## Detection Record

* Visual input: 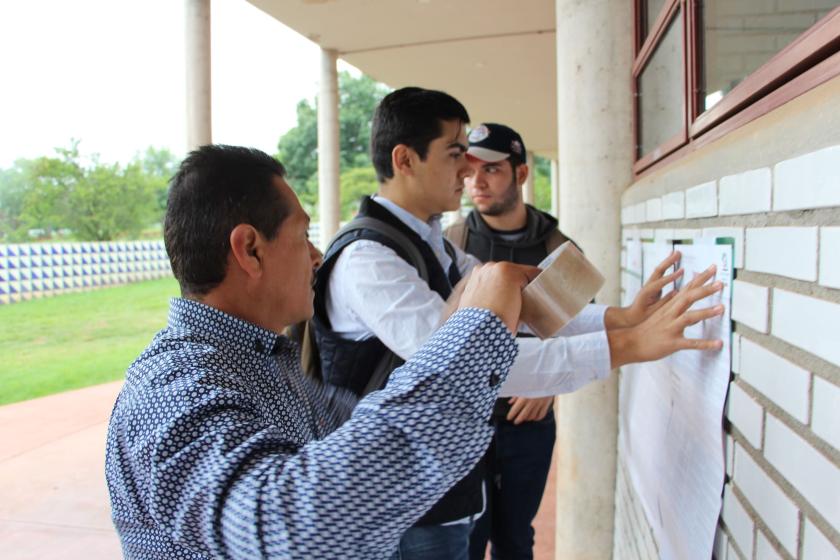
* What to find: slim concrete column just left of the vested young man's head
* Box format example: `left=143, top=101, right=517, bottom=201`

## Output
left=318, top=49, right=341, bottom=249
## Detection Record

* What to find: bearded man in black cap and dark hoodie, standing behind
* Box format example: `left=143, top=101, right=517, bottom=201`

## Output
left=446, top=123, right=568, bottom=559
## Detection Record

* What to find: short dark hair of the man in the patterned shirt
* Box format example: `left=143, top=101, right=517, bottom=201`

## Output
left=163, top=145, right=290, bottom=296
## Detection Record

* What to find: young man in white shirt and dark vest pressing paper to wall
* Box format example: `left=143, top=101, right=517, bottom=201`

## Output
left=315, top=88, right=722, bottom=560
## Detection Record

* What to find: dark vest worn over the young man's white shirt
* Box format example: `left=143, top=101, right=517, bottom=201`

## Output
left=312, top=197, right=483, bottom=525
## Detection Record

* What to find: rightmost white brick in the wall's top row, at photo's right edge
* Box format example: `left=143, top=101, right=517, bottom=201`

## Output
left=773, top=146, right=840, bottom=211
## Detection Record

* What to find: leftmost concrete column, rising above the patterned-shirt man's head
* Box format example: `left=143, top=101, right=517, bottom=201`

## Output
left=184, top=0, right=213, bottom=150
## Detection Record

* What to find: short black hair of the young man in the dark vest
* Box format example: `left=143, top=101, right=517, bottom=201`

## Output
left=370, top=87, right=470, bottom=183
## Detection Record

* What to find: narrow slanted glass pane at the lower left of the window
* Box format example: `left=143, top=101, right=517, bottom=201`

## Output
left=636, top=11, right=685, bottom=157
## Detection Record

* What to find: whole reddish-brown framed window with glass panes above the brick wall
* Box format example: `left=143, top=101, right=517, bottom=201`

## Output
left=633, top=0, right=840, bottom=174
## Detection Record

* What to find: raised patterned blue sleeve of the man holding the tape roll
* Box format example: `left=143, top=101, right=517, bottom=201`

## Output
left=153, top=309, right=516, bottom=558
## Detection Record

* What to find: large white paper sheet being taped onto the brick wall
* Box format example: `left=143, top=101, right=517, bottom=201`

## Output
left=620, top=241, right=732, bottom=560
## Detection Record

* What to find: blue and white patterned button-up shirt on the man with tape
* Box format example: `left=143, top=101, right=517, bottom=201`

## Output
left=106, top=299, right=516, bottom=559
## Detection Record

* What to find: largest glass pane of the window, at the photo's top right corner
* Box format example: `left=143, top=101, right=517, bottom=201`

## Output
left=699, top=0, right=840, bottom=112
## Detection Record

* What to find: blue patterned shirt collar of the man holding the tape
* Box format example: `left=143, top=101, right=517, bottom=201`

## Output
left=169, top=298, right=292, bottom=356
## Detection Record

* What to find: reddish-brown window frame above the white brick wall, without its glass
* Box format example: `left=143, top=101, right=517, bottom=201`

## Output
left=632, top=0, right=840, bottom=177
